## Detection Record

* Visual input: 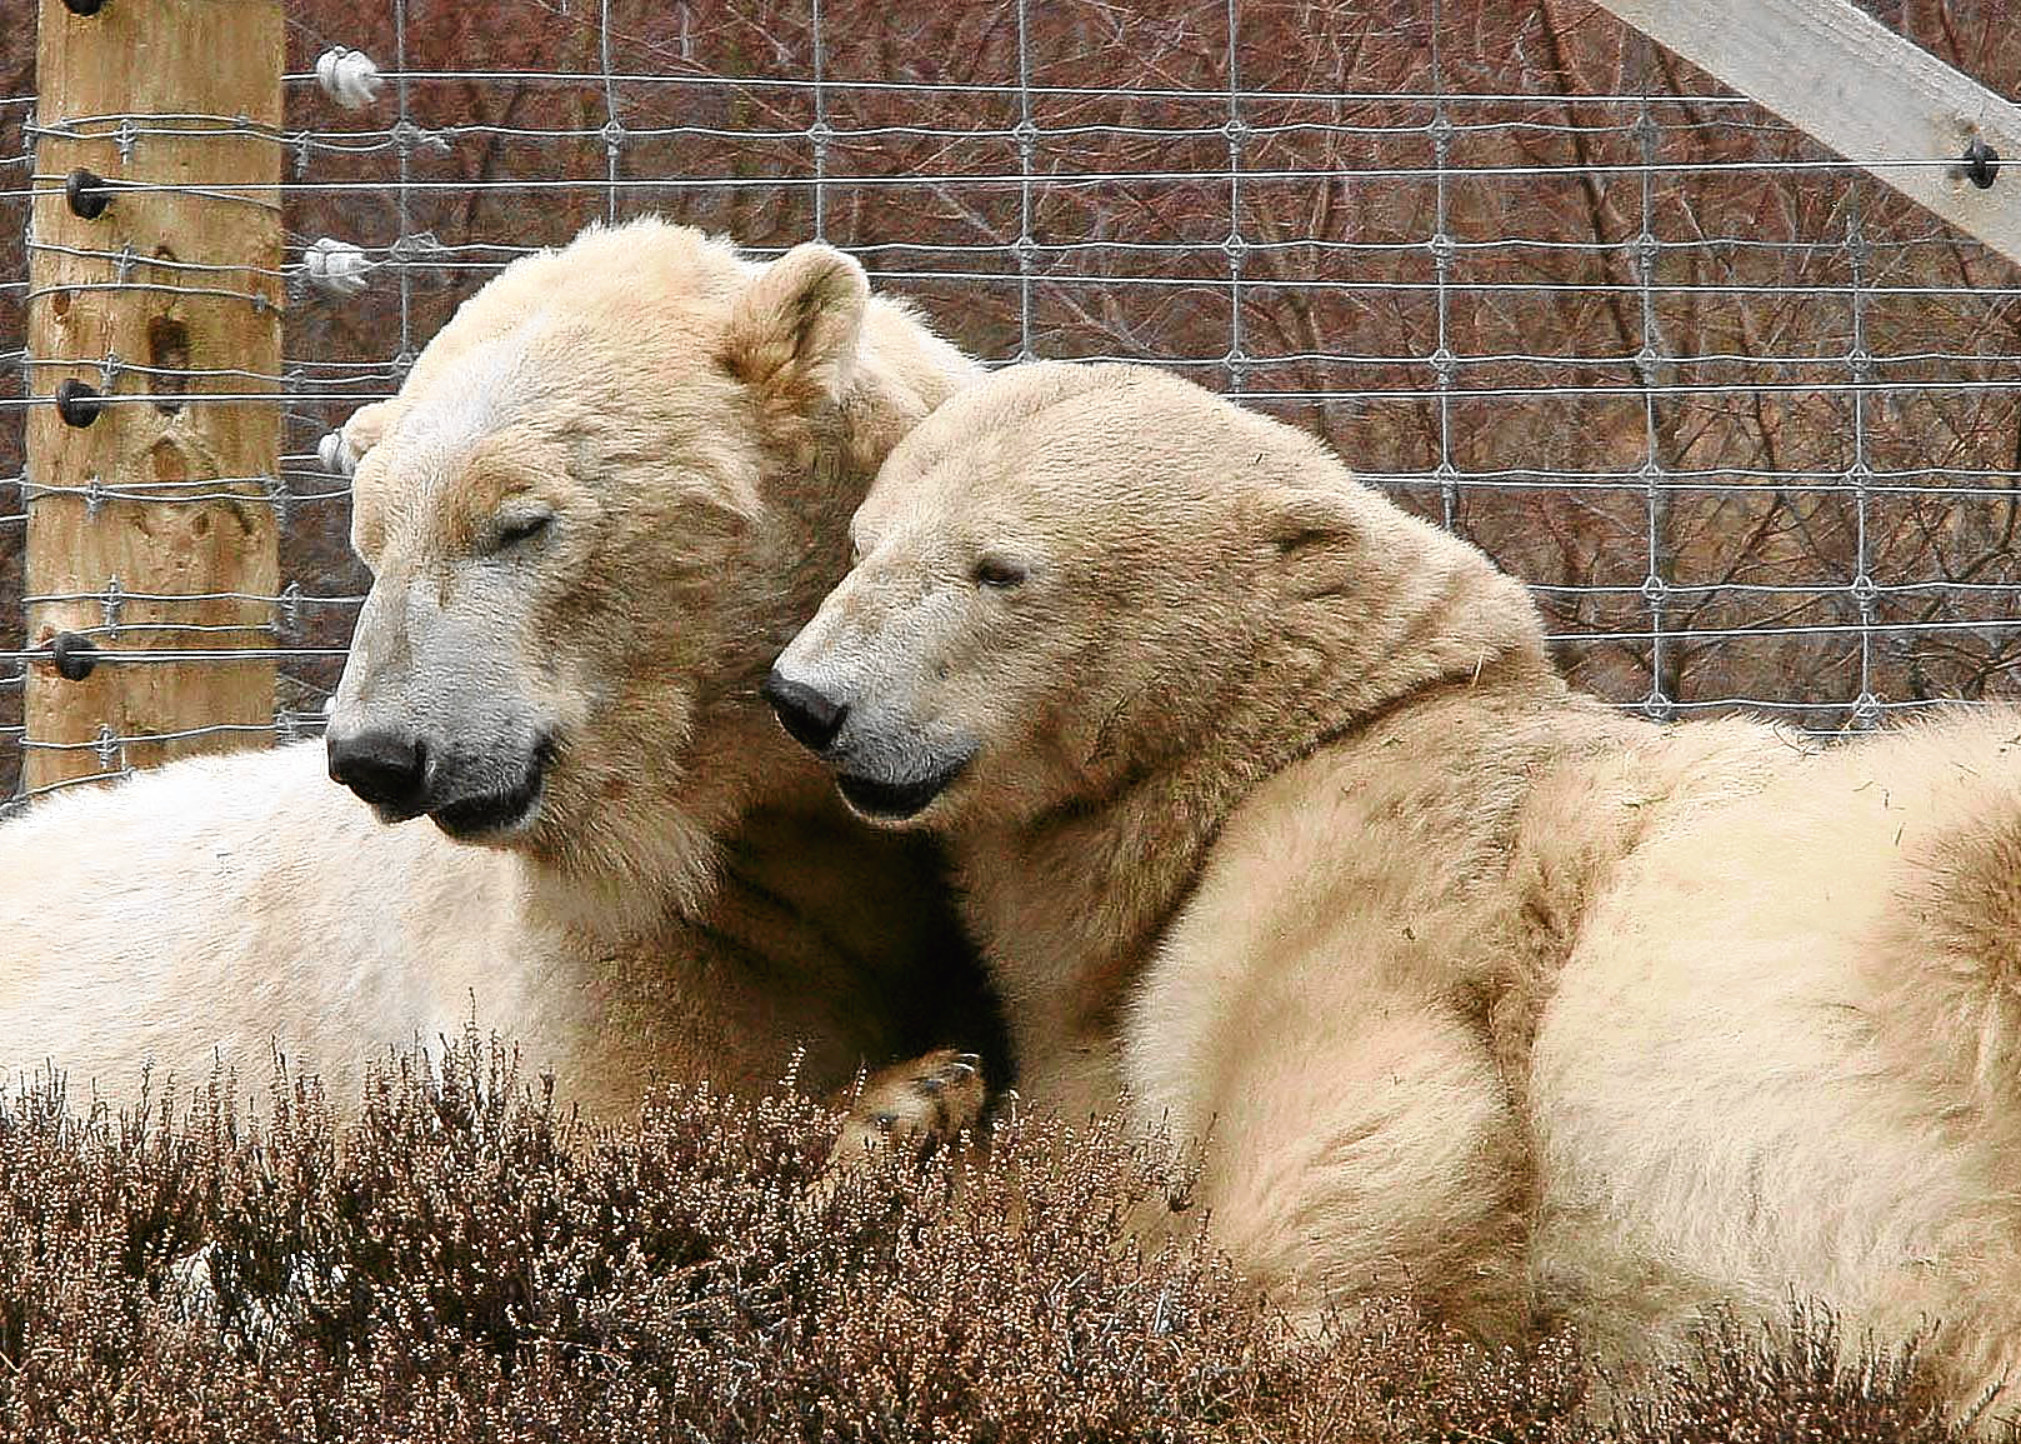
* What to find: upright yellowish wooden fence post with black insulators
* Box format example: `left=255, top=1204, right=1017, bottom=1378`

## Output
left=22, top=0, right=285, bottom=789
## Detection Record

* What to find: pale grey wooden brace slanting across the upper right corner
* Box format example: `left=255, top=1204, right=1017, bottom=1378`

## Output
left=1599, top=0, right=2021, bottom=263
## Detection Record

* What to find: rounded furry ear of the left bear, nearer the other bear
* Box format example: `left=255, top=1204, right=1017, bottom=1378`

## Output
left=721, top=241, right=871, bottom=402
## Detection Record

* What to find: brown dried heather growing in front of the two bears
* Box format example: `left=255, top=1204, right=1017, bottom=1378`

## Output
left=0, top=1033, right=1988, bottom=1444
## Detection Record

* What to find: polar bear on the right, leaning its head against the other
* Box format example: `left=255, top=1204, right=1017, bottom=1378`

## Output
left=766, top=364, right=2021, bottom=1408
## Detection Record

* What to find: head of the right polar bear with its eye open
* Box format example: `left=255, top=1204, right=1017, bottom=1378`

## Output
left=766, top=362, right=1542, bottom=825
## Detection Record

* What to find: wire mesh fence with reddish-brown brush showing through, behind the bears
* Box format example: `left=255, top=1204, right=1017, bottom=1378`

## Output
left=0, top=0, right=2021, bottom=796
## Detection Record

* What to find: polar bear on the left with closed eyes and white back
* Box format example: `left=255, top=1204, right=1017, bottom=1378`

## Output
left=0, top=220, right=1006, bottom=1112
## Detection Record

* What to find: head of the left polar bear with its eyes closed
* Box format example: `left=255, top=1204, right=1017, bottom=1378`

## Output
left=327, top=220, right=970, bottom=896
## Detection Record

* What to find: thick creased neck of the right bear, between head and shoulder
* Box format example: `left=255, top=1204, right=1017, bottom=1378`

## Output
left=958, top=489, right=1566, bottom=1075
